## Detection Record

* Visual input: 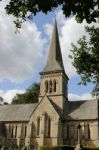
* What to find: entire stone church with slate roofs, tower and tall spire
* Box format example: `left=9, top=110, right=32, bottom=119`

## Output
left=0, top=21, right=99, bottom=146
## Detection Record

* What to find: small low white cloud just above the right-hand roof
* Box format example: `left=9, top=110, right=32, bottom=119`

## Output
left=68, top=93, right=95, bottom=101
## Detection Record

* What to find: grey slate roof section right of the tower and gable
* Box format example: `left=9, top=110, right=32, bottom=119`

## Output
left=64, top=100, right=98, bottom=120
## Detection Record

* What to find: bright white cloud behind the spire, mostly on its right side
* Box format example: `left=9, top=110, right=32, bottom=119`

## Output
left=45, top=10, right=97, bottom=77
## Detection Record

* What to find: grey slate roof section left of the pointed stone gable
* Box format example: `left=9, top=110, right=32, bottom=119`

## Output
left=0, top=103, right=37, bottom=122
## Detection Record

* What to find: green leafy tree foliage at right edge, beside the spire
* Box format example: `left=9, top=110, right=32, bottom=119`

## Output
left=70, top=26, right=99, bottom=94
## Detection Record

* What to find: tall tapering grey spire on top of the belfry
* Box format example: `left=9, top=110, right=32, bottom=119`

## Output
left=42, top=20, right=64, bottom=73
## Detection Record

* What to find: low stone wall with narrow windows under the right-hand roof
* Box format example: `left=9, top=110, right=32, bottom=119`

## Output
left=63, top=120, right=99, bottom=147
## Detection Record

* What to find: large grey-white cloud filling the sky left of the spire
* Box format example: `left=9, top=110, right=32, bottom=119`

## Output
left=0, top=1, right=46, bottom=83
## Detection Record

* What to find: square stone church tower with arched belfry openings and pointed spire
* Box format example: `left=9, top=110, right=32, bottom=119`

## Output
left=39, top=20, right=68, bottom=109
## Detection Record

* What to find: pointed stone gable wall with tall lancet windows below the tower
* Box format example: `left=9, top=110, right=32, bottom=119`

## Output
left=27, top=96, right=59, bottom=146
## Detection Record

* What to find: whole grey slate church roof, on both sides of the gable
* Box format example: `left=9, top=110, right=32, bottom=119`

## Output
left=0, top=99, right=98, bottom=122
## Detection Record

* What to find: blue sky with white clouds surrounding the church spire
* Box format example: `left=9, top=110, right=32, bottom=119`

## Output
left=0, top=0, right=97, bottom=102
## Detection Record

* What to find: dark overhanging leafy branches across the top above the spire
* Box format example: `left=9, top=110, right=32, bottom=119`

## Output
left=2, top=0, right=99, bottom=28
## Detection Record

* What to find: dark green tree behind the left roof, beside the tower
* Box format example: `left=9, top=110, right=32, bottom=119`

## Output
left=12, top=83, right=40, bottom=104
